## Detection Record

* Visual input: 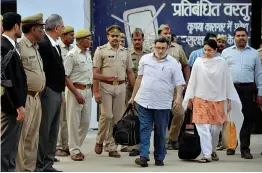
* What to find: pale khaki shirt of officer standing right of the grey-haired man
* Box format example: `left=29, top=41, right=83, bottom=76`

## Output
left=64, top=46, right=93, bottom=85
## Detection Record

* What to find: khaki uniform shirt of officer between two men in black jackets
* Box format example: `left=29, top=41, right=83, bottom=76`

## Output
left=19, top=36, right=46, bottom=92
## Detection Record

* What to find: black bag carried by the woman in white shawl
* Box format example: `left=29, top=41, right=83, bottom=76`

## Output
left=178, top=109, right=201, bottom=160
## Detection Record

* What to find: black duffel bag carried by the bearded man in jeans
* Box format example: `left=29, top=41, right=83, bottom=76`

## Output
left=113, top=104, right=140, bottom=146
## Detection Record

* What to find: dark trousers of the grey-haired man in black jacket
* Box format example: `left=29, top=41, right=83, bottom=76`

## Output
left=35, top=87, right=62, bottom=172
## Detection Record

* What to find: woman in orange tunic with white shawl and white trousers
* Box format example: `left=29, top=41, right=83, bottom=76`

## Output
left=183, top=40, right=243, bottom=163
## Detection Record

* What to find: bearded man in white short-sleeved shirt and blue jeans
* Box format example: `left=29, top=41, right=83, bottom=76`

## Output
left=129, top=36, right=185, bottom=167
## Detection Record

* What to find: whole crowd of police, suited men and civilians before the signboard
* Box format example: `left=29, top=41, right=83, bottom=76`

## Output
left=1, top=12, right=262, bottom=172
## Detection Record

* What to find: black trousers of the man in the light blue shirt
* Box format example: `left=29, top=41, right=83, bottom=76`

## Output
left=235, top=84, right=255, bottom=153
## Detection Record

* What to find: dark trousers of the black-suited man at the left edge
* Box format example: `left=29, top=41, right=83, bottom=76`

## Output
left=1, top=112, right=23, bottom=172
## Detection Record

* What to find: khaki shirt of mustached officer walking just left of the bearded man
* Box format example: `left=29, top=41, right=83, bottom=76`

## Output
left=94, top=43, right=133, bottom=81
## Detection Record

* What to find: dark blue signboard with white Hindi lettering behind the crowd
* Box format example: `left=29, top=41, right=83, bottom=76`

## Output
left=93, top=0, right=251, bottom=54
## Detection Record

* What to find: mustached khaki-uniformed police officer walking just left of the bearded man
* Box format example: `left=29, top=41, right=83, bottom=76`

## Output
left=94, top=25, right=135, bottom=158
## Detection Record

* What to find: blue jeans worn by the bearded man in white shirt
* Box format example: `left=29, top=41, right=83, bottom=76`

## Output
left=138, top=104, right=170, bottom=161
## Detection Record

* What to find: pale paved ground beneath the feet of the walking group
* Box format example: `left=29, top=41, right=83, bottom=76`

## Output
left=54, top=131, right=262, bottom=172
